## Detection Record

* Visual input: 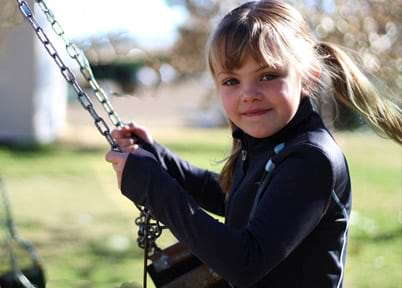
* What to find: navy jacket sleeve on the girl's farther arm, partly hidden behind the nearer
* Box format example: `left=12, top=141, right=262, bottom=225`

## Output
left=133, top=142, right=225, bottom=216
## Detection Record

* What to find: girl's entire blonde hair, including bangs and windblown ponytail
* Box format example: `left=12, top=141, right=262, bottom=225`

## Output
left=208, top=0, right=402, bottom=191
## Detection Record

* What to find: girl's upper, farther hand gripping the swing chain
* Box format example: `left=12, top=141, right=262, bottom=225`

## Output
left=111, top=122, right=154, bottom=153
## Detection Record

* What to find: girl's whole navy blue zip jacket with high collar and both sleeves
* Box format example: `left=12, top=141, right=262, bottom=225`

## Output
left=121, top=98, right=351, bottom=288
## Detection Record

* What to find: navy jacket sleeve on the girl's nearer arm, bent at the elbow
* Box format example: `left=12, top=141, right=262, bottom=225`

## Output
left=122, top=147, right=333, bottom=287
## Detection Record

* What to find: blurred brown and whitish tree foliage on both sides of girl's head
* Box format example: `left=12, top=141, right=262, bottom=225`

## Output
left=169, top=0, right=402, bottom=83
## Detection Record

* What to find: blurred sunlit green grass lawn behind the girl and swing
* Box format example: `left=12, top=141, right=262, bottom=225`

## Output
left=0, top=130, right=402, bottom=288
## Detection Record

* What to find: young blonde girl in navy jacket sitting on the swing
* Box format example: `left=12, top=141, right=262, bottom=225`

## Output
left=106, top=0, right=402, bottom=288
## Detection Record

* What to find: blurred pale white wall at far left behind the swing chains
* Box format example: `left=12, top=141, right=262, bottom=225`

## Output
left=0, top=2, right=67, bottom=144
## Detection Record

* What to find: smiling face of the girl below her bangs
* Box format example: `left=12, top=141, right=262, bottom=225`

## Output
left=216, top=56, right=301, bottom=138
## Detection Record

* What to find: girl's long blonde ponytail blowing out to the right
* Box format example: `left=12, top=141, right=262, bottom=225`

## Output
left=316, top=42, right=402, bottom=144
